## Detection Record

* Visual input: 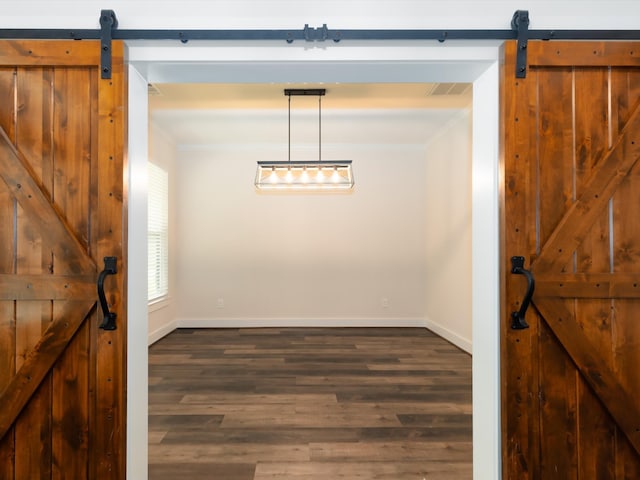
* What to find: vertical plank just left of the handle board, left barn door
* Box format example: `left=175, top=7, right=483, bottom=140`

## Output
left=52, top=64, right=95, bottom=479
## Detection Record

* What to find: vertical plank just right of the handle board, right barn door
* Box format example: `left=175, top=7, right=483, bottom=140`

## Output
left=535, top=68, right=578, bottom=479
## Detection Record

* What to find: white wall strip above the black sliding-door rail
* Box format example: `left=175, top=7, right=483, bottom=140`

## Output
left=5, top=0, right=640, bottom=29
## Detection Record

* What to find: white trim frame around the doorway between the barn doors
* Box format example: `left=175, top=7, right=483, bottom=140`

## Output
left=129, top=39, right=500, bottom=473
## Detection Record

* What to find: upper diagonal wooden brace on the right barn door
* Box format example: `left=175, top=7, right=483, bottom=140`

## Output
left=532, top=97, right=640, bottom=271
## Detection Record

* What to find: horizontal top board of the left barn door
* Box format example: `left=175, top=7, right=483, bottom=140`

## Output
left=0, top=40, right=100, bottom=67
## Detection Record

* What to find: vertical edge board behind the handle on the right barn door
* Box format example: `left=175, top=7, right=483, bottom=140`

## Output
left=501, top=42, right=540, bottom=479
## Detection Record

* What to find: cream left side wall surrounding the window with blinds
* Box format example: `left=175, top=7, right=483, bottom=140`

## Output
left=149, top=123, right=178, bottom=344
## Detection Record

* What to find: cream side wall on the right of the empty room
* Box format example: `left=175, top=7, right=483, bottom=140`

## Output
left=424, top=111, right=472, bottom=352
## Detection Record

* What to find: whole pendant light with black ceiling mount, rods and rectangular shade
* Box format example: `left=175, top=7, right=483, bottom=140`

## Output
left=255, top=88, right=353, bottom=190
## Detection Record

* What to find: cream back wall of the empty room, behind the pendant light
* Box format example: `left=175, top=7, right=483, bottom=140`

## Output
left=170, top=107, right=471, bottom=332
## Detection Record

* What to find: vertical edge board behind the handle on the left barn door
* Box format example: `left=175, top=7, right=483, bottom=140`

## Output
left=89, top=41, right=127, bottom=480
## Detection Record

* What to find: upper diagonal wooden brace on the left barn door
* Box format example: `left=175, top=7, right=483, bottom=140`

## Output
left=0, top=129, right=96, bottom=273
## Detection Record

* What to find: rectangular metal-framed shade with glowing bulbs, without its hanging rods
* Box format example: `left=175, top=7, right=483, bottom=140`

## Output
left=255, top=160, right=353, bottom=190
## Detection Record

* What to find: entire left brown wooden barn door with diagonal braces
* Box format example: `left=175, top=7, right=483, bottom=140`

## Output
left=0, top=41, right=126, bottom=480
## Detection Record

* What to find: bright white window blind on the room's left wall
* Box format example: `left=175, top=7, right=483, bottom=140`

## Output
left=147, top=163, right=169, bottom=302
